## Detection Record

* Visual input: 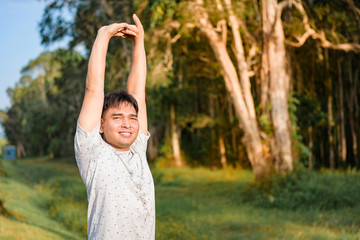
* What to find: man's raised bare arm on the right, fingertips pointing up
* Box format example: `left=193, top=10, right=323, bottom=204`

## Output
left=127, top=14, right=148, bottom=135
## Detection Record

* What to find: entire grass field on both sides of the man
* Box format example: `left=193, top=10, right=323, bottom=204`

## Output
left=0, top=158, right=360, bottom=240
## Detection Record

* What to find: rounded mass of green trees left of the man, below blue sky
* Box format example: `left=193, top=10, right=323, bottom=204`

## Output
left=3, top=49, right=85, bottom=157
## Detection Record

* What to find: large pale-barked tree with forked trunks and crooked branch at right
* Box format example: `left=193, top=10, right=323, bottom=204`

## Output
left=146, top=0, right=359, bottom=179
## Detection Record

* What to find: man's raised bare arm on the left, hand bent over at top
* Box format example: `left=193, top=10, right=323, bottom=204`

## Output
left=78, top=23, right=136, bottom=132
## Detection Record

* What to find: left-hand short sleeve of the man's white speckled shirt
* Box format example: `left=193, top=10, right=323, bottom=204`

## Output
left=74, top=123, right=101, bottom=181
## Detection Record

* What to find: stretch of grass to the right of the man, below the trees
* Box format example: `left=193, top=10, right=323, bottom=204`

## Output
left=153, top=169, right=360, bottom=240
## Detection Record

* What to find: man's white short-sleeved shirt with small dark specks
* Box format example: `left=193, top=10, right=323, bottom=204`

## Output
left=74, top=124, right=155, bottom=240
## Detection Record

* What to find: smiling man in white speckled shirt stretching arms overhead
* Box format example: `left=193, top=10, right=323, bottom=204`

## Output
left=74, top=14, right=155, bottom=240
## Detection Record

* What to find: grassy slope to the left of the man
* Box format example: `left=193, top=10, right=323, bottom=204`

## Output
left=0, top=159, right=86, bottom=239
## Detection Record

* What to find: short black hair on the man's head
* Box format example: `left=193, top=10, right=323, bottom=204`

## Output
left=101, top=91, right=139, bottom=117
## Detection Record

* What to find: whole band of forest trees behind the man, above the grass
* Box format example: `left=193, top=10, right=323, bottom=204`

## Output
left=1, top=0, right=360, bottom=180
